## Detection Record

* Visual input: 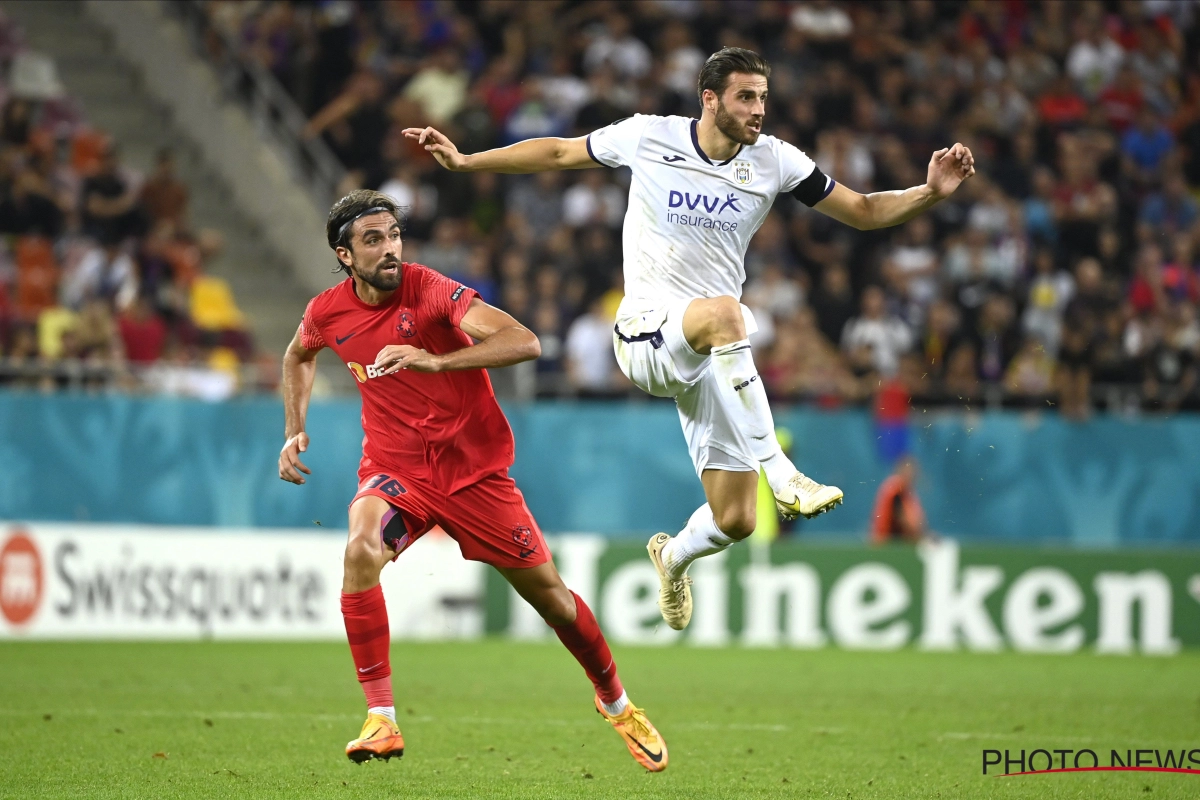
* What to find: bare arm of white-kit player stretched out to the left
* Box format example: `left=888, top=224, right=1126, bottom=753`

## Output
left=404, top=128, right=601, bottom=174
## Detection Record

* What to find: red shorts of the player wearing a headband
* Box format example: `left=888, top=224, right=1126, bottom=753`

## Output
left=350, top=471, right=550, bottom=569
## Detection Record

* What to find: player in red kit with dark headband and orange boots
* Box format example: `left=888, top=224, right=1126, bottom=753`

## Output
left=280, top=190, right=667, bottom=772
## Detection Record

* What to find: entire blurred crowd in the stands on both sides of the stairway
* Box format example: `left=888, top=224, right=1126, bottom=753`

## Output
left=0, top=0, right=1200, bottom=419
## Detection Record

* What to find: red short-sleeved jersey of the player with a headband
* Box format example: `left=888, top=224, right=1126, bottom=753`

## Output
left=300, top=263, right=514, bottom=494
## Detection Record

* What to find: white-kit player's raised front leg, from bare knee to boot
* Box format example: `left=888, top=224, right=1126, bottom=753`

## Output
left=683, top=295, right=842, bottom=519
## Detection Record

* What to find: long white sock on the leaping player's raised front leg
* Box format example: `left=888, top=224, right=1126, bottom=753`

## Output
left=712, top=339, right=796, bottom=492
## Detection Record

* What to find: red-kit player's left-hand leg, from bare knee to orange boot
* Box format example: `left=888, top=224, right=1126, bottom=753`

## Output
left=342, top=495, right=404, bottom=764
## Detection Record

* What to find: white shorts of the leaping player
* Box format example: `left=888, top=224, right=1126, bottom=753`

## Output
left=612, top=299, right=758, bottom=475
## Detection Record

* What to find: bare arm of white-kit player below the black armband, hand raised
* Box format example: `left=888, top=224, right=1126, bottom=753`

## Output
left=812, top=144, right=974, bottom=230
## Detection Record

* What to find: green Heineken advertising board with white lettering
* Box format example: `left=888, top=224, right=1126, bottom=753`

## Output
left=484, top=536, right=1200, bottom=655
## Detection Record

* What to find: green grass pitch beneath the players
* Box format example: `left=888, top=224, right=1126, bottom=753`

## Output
left=0, top=640, right=1200, bottom=800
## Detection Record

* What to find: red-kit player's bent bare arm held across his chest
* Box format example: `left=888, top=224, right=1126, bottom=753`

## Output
left=374, top=297, right=541, bottom=375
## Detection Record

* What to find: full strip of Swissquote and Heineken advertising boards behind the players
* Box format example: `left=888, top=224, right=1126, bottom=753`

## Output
left=0, top=524, right=1200, bottom=655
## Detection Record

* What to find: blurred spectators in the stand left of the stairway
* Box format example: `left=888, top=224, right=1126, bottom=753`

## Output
left=0, top=14, right=254, bottom=397
